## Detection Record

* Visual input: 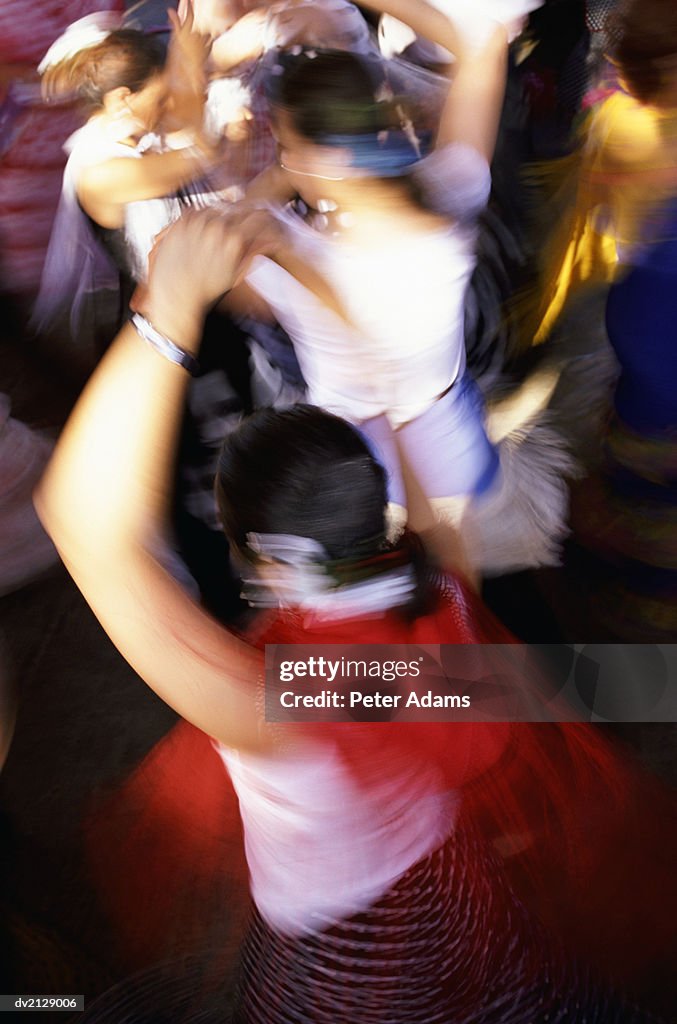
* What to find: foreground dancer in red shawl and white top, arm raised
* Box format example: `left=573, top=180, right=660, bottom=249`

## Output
left=37, top=213, right=671, bottom=1024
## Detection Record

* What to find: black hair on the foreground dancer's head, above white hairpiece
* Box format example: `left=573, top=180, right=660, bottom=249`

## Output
left=215, top=406, right=387, bottom=559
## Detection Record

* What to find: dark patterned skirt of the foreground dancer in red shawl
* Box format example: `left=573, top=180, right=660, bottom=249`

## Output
left=232, top=826, right=649, bottom=1024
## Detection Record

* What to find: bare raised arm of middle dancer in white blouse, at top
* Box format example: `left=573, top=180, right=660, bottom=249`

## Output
left=364, top=0, right=508, bottom=161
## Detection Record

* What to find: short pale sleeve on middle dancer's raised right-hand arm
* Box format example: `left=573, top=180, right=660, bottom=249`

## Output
left=414, top=142, right=492, bottom=222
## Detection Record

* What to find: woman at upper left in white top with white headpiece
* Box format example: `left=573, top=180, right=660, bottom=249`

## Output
left=34, top=14, right=248, bottom=614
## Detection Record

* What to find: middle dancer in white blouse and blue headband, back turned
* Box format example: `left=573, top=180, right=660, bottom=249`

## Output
left=234, top=0, right=570, bottom=573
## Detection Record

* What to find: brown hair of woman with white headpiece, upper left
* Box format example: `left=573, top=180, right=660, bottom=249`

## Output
left=42, top=29, right=165, bottom=106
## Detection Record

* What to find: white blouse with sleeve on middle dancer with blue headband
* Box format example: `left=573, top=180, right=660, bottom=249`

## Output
left=247, top=143, right=491, bottom=426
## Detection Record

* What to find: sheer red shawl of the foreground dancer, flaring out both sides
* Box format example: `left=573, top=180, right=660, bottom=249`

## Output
left=88, top=584, right=677, bottom=996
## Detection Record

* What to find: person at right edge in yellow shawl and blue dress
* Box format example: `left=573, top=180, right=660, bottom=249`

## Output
left=561, top=0, right=677, bottom=642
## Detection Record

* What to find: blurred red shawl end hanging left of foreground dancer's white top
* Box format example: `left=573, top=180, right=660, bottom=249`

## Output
left=86, top=722, right=249, bottom=971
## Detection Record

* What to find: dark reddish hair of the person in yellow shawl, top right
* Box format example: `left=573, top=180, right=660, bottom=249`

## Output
left=611, top=0, right=677, bottom=102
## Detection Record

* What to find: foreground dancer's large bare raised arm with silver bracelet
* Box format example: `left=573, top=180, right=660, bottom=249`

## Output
left=36, top=214, right=271, bottom=750
